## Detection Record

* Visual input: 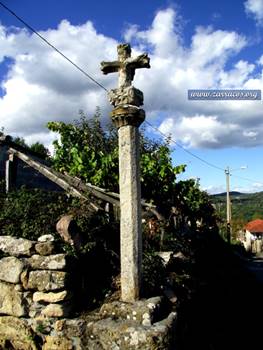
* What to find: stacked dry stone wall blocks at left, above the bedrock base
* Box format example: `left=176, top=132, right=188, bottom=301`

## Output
left=0, top=235, right=72, bottom=317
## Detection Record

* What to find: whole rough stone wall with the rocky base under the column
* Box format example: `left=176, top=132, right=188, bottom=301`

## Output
left=0, top=235, right=177, bottom=350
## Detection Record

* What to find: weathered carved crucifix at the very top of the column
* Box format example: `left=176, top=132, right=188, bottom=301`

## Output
left=101, top=44, right=150, bottom=88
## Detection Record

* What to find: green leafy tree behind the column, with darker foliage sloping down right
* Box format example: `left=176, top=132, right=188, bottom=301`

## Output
left=48, top=109, right=217, bottom=227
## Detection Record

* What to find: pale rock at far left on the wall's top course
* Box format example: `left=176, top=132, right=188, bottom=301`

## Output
left=0, top=236, right=35, bottom=256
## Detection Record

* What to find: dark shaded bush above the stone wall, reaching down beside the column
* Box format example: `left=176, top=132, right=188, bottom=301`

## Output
left=0, top=187, right=120, bottom=310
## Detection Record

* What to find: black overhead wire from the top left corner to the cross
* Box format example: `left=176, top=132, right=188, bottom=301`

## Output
left=0, top=1, right=108, bottom=92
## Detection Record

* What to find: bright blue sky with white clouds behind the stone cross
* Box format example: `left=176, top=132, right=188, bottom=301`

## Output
left=0, top=0, right=263, bottom=193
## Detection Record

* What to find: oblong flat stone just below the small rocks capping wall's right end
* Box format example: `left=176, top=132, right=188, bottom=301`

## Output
left=28, top=254, right=66, bottom=270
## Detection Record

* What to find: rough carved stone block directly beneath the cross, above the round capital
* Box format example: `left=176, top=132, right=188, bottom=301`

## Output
left=108, top=86, right=143, bottom=107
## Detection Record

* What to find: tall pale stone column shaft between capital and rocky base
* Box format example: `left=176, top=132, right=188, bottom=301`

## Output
left=118, top=125, right=142, bottom=302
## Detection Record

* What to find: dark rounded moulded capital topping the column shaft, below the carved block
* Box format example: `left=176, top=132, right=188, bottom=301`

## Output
left=110, top=105, right=145, bottom=129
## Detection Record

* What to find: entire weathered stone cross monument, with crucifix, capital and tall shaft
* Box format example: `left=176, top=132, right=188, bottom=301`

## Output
left=101, top=44, right=150, bottom=302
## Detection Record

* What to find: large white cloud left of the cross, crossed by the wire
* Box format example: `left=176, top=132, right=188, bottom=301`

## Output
left=0, top=21, right=117, bottom=144
